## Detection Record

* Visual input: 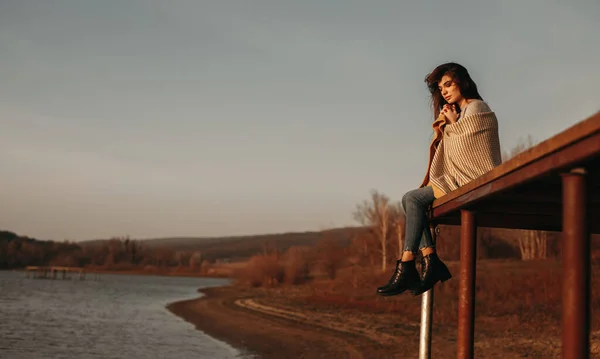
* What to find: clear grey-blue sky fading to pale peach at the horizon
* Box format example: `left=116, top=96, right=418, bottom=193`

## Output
left=0, top=0, right=600, bottom=240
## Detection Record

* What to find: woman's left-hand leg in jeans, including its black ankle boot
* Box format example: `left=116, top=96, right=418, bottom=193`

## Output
left=377, top=187, right=435, bottom=296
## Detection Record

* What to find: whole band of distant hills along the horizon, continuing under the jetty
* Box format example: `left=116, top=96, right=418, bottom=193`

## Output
left=7, top=226, right=600, bottom=269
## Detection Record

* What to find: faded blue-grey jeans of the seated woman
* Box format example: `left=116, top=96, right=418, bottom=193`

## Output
left=402, top=186, right=435, bottom=253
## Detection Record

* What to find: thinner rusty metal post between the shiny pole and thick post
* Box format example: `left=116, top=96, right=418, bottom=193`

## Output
left=457, top=209, right=477, bottom=359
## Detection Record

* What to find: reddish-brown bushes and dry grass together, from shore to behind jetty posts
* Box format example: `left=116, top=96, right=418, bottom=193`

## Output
left=223, top=231, right=600, bottom=358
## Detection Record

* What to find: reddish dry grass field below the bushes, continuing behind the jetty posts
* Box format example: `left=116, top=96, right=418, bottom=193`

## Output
left=231, top=260, right=600, bottom=358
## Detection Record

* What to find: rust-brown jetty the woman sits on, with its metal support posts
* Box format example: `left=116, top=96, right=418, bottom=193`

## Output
left=419, top=112, right=600, bottom=359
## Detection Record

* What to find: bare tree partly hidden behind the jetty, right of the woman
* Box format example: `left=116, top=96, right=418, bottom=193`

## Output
left=502, top=135, right=548, bottom=260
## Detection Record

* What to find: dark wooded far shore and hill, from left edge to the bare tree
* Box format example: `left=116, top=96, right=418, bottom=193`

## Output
left=0, top=227, right=370, bottom=273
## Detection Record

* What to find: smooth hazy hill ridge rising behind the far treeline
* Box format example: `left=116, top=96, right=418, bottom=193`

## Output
left=79, top=227, right=367, bottom=260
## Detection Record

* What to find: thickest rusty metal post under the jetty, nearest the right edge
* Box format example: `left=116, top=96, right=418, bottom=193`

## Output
left=562, top=170, right=590, bottom=359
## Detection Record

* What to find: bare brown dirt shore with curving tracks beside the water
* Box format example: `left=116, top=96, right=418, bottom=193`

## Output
left=166, top=285, right=392, bottom=359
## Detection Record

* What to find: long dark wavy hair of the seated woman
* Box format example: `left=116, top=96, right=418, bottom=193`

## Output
left=425, top=62, right=483, bottom=119
